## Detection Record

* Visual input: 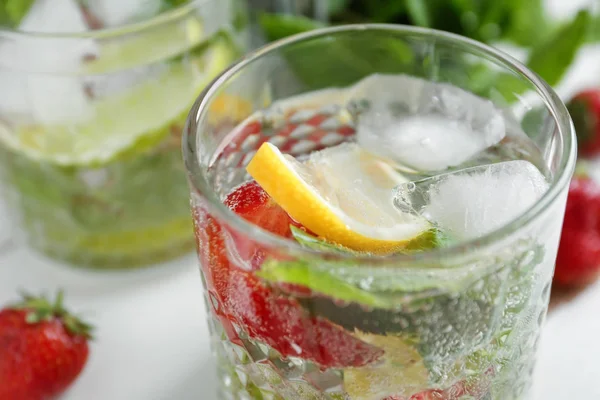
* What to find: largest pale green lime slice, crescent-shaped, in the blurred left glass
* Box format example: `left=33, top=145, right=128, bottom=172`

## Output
left=0, top=40, right=236, bottom=166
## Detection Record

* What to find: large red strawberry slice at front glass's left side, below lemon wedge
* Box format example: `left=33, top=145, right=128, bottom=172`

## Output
left=194, top=182, right=383, bottom=368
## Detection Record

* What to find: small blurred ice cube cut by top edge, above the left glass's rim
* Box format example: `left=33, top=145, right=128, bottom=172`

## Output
left=87, top=0, right=161, bottom=26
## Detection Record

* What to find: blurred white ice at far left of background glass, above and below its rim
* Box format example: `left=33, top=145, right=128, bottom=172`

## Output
left=0, top=0, right=96, bottom=124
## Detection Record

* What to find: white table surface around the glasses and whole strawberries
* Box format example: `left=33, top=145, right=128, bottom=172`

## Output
left=0, top=7, right=600, bottom=400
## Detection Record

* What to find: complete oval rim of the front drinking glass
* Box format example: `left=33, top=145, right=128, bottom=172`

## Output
left=182, top=24, right=577, bottom=269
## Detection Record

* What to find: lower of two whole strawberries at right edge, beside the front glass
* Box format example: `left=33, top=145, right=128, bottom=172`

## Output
left=554, top=176, right=600, bottom=286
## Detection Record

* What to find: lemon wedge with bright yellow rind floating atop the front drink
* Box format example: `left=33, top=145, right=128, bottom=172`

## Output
left=247, top=142, right=432, bottom=254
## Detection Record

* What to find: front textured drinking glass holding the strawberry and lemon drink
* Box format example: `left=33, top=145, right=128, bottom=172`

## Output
left=183, top=24, right=576, bottom=400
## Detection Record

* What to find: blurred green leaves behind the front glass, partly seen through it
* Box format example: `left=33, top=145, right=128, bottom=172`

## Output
left=259, top=0, right=600, bottom=93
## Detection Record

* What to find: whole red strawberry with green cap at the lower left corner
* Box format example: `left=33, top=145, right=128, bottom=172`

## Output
left=0, top=292, right=91, bottom=400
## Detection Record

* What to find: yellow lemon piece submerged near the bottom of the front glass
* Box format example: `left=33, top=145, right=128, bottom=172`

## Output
left=344, top=332, right=429, bottom=400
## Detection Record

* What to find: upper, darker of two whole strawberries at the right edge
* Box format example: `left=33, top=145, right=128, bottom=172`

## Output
left=567, top=88, right=600, bottom=157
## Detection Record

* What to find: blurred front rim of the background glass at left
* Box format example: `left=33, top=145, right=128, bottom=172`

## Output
left=0, top=0, right=213, bottom=40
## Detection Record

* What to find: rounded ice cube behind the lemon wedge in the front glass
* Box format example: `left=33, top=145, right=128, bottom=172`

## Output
left=351, top=74, right=506, bottom=171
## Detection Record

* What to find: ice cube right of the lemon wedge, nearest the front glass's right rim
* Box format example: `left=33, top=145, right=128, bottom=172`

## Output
left=394, top=160, right=548, bottom=240
